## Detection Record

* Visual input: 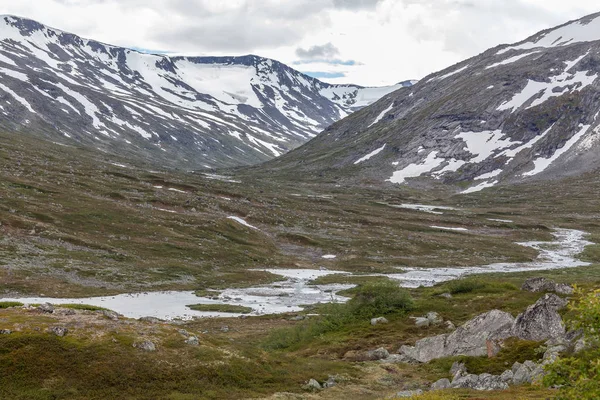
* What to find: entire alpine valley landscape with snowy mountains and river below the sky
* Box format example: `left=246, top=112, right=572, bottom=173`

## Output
left=0, top=7, right=600, bottom=400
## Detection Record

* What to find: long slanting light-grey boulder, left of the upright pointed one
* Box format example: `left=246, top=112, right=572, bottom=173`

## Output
left=400, top=310, right=514, bottom=363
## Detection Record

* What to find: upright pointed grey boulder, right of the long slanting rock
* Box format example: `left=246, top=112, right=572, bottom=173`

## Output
left=512, top=294, right=567, bottom=341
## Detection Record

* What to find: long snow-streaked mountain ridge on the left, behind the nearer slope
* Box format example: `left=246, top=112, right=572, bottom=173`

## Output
left=0, top=16, right=406, bottom=168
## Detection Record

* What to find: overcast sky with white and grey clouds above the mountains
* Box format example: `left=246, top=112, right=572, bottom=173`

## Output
left=0, top=0, right=600, bottom=85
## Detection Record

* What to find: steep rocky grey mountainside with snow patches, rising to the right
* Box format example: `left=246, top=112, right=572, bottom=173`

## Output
left=267, top=13, right=600, bottom=193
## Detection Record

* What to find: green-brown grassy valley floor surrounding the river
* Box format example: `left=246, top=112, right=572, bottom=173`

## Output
left=0, top=134, right=600, bottom=399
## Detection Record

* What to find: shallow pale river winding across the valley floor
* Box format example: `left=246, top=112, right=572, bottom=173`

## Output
left=0, top=229, right=593, bottom=319
